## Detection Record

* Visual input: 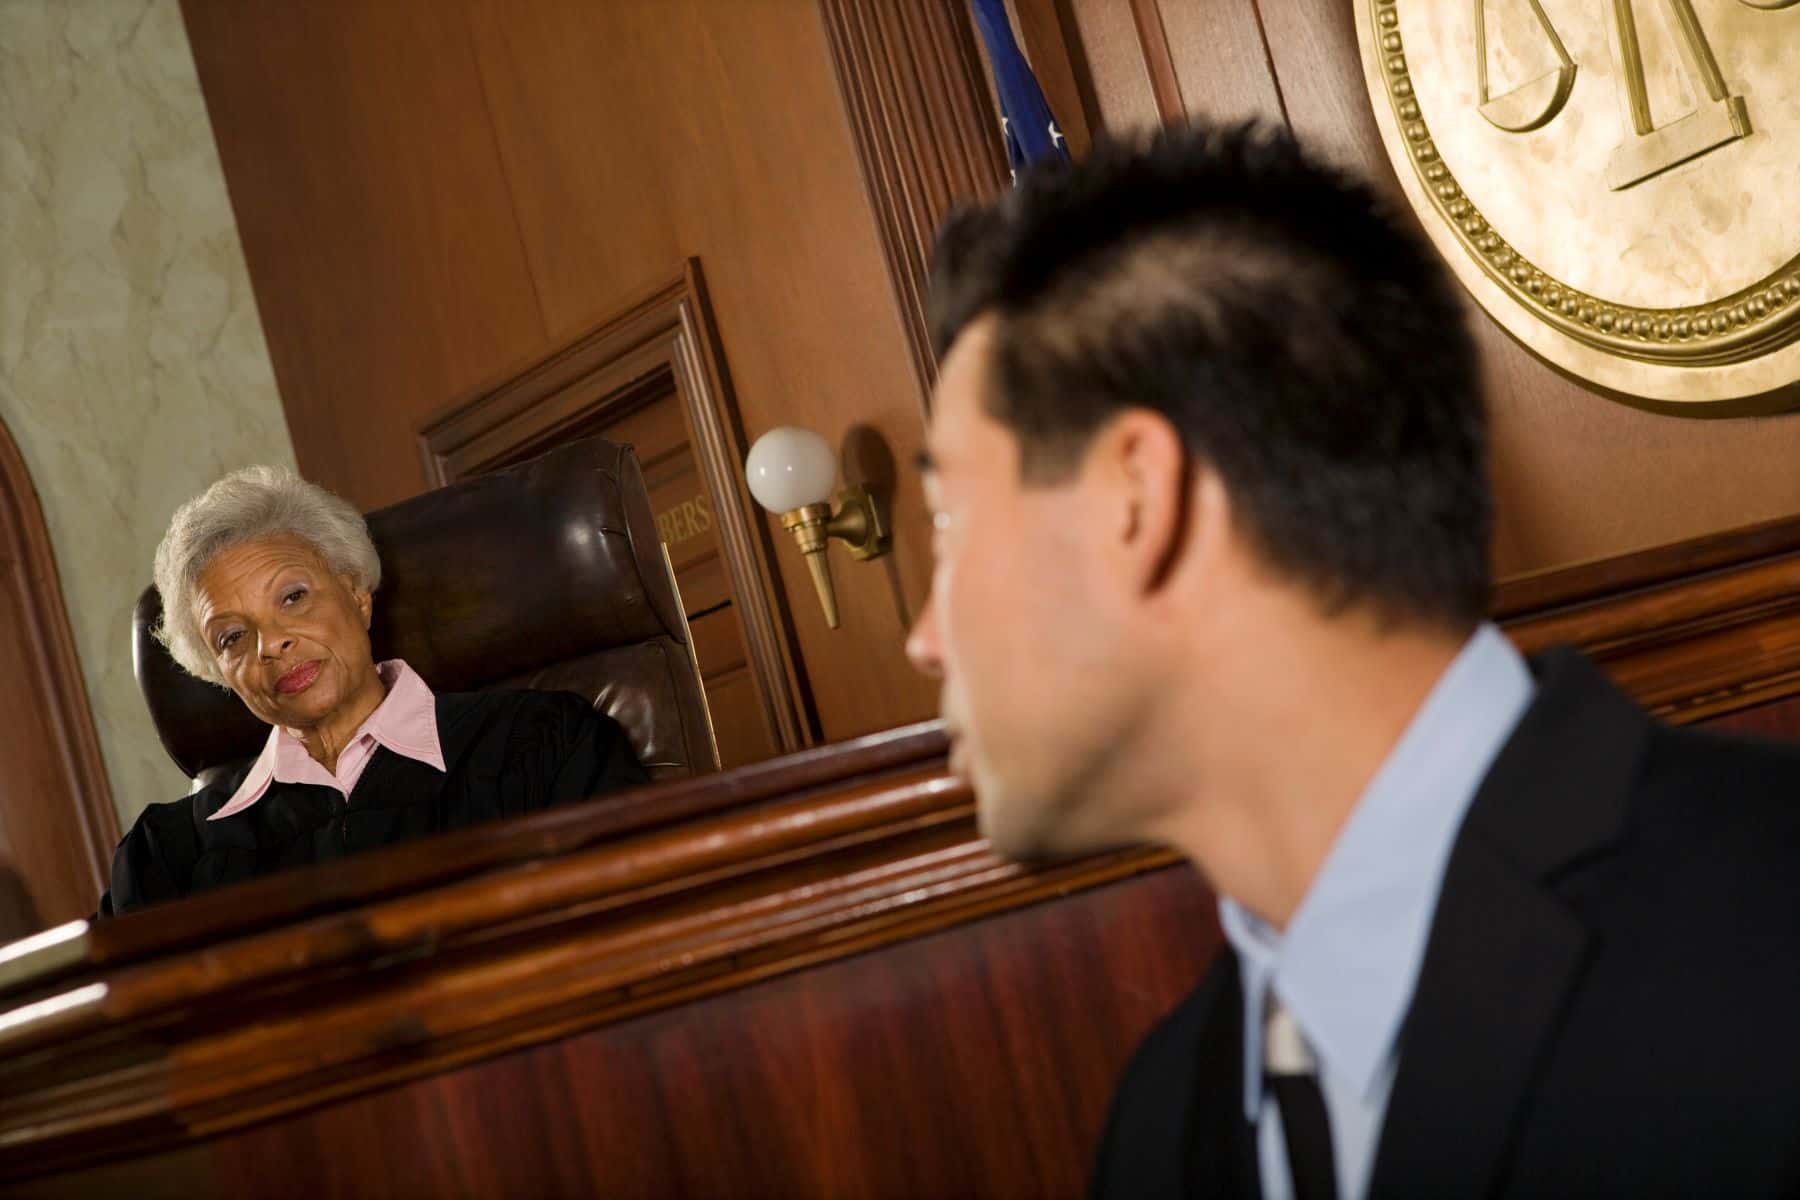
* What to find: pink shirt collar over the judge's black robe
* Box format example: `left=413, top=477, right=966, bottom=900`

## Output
left=207, top=658, right=445, bottom=820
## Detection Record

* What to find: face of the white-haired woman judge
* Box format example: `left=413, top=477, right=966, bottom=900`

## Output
left=194, top=534, right=380, bottom=730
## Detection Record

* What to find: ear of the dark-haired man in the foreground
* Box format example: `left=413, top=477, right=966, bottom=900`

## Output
left=1096, top=408, right=1192, bottom=592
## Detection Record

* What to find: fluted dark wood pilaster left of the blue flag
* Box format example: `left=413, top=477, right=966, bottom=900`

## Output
left=819, top=0, right=1008, bottom=401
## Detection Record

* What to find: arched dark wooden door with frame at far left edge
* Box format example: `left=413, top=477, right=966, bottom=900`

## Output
left=0, top=425, right=119, bottom=941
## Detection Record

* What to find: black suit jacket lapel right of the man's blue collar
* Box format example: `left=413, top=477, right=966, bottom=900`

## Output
left=1370, top=651, right=1651, bottom=1196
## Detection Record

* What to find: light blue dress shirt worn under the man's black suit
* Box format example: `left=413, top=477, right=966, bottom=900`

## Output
left=1219, top=624, right=1535, bottom=1200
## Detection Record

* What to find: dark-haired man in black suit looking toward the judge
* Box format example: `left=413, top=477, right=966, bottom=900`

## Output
left=909, top=128, right=1800, bottom=1200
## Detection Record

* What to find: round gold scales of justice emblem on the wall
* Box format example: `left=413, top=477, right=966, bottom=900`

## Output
left=1355, top=0, right=1800, bottom=416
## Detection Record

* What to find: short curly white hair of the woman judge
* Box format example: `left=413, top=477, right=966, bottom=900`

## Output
left=157, top=466, right=382, bottom=685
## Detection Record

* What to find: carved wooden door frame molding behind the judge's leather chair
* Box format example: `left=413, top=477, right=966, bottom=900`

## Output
left=418, top=259, right=817, bottom=752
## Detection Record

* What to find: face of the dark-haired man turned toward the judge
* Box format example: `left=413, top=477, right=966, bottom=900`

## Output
left=907, top=318, right=1130, bottom=858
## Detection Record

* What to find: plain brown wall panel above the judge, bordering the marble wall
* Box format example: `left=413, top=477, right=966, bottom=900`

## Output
left=182, top=0, right=545, bottom=509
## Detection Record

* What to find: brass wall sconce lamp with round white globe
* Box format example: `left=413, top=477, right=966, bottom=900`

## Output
left=743, top=425, right=889, bottom=630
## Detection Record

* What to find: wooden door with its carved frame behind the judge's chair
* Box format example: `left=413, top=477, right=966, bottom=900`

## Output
left=418, top=259, right=819, bottom=766
